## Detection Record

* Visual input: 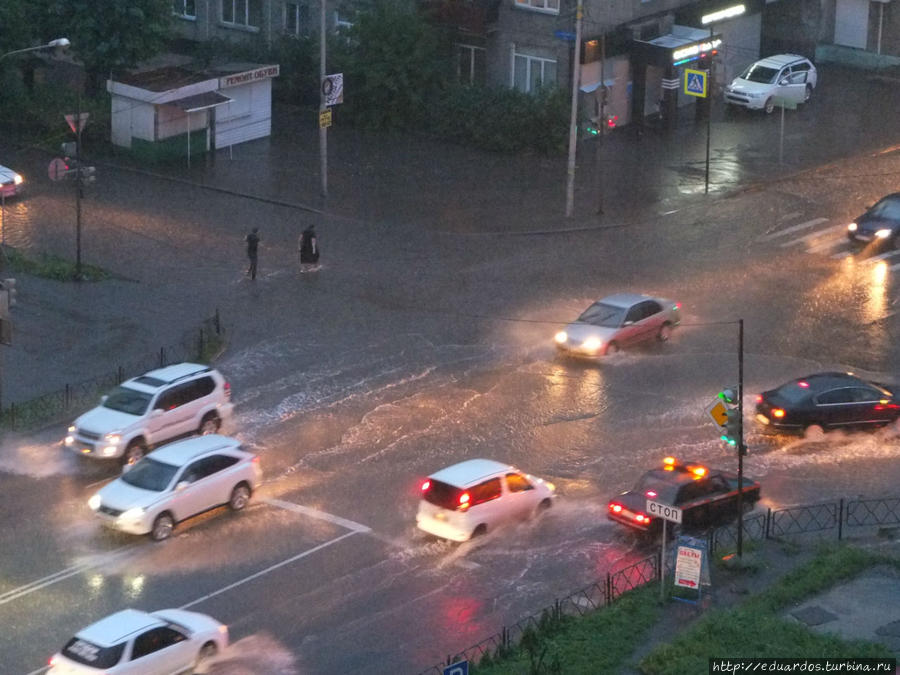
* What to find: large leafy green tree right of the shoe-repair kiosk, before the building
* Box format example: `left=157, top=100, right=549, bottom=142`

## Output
left=329, top=0, right=450, bottom=129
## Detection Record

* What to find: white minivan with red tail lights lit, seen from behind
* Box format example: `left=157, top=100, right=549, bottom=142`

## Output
left=416, top=459, right=556, bottom=541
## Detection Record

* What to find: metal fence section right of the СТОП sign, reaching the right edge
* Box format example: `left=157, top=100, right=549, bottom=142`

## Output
left=709, top=497, right=900, bottom=553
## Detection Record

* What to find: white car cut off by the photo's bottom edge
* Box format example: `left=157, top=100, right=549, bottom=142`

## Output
left=48, top=609, right=228, bottom=675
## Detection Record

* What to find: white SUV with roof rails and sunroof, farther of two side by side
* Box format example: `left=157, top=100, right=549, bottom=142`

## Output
left=65, top=363, right=233, bottom=464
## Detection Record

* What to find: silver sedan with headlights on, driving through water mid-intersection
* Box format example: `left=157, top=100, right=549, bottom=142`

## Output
left=554, top=293, right=681, bottom=357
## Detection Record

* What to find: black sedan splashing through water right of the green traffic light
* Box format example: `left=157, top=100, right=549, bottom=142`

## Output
left=756, top=372, right=900, bottom=435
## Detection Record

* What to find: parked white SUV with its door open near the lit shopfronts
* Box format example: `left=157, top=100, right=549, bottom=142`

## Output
left=725, top=54, right=817, bottom=113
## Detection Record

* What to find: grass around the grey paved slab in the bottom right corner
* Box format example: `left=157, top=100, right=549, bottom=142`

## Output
left=640, top=545, right=898, bottom=675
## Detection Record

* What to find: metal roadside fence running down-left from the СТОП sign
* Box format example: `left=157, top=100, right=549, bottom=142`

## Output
left=419, top=552, right=659, bottom=675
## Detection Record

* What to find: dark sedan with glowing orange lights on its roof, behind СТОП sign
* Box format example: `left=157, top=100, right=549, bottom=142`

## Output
left=606, top=457, right=760, bottom=534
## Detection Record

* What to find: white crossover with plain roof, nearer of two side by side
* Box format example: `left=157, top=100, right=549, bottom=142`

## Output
left=88, top=434, right=262, bottom=541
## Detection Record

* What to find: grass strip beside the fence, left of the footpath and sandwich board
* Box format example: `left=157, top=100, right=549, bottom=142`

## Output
left=472, top=584, right=662, bottom=675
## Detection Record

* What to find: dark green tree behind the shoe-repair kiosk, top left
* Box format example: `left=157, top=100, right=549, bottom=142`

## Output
left=37, top=0, right=172, bottom=92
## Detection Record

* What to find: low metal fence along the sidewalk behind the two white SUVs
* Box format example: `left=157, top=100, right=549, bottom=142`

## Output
left=0, top=309, right=223, bottom=430
